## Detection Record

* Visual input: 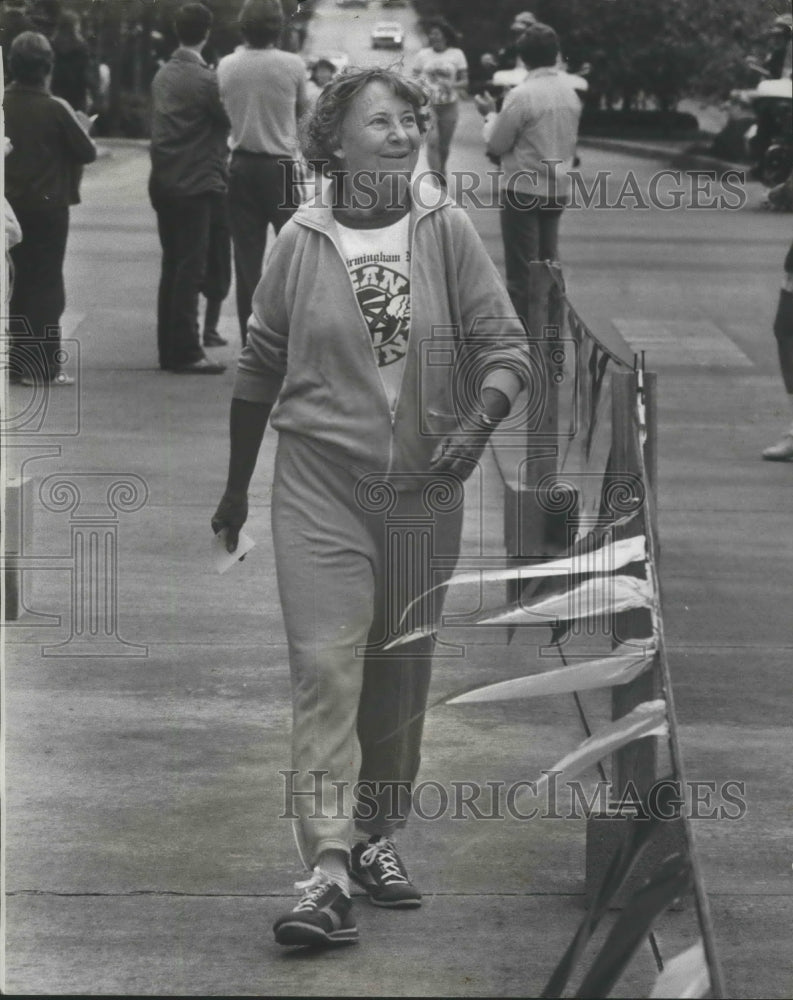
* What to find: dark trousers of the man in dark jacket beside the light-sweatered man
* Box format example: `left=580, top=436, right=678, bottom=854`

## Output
left=149, top=183, right=226, bottom=368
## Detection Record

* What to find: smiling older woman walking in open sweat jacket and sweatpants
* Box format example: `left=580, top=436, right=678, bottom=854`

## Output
left=212, top=69, right=528, bottom=945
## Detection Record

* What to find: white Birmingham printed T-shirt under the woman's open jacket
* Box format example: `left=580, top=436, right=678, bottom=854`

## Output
left=336, top=215, right=410, bottom=410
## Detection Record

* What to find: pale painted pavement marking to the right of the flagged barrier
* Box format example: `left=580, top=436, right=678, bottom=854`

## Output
left=612, top=319, right=754, bottom=368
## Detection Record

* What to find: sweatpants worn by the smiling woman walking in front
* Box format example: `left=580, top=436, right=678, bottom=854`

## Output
left=272, top=428, right=463, bottom=865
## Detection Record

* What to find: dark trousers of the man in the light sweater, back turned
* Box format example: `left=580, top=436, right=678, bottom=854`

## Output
left=229, top=150, right=299, bottom=344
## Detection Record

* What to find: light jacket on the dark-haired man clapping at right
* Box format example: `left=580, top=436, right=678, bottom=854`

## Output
left=484, top=66, right=581, bottom=201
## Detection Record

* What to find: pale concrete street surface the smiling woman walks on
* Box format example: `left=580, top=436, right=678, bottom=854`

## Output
left=6, top=3, right=793, bottom=997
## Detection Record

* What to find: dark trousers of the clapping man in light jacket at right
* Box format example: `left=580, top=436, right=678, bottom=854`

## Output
left=500, top=190, right=563, bottom=320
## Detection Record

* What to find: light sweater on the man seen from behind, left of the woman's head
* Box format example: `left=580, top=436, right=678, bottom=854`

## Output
left=218, top=45, right=308, bottom=158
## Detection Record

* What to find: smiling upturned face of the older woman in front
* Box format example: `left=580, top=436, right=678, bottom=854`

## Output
left=334, top=80, right=421, bottom=184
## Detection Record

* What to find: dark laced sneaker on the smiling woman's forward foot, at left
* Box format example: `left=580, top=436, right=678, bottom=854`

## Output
left=273, top=868, right=358, bottom=947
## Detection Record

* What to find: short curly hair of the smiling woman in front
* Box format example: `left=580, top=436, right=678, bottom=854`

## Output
left=300, top=67, right=430, bottom=176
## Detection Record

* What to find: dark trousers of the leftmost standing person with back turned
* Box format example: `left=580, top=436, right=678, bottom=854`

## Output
left=8, top=208, right=69, bottom=382
